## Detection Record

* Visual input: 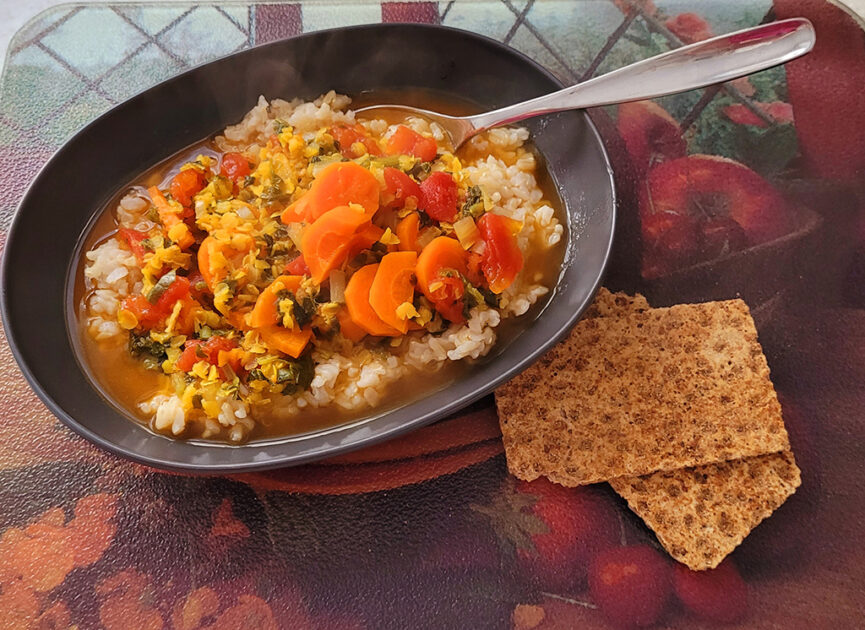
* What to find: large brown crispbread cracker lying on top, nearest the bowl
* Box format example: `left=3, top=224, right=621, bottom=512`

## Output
left=496, top=300, right=789, bottom=486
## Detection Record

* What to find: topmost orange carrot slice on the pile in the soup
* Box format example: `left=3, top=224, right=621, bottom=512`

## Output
left=282, top=162, right=380, bottom=224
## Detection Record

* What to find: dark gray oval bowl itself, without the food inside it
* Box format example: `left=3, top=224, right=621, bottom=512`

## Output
left=2, top=24, right=615, bottom=472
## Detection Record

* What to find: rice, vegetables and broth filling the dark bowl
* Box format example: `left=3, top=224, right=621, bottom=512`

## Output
left=77, top=92, right=564, bottom=443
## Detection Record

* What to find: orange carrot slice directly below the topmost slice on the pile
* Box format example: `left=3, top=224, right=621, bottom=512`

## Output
left=300, top=206, right=369, bottom=284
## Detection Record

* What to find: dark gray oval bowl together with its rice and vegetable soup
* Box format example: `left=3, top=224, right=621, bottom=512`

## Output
left=2, top=24, right=615, bottom=472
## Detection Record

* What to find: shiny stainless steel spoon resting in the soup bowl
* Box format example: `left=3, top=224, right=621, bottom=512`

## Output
left=357, top=18, right=815, bottom=149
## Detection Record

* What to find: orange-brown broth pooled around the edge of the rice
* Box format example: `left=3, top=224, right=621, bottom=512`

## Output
left=74, top=91, right=567, bottom=442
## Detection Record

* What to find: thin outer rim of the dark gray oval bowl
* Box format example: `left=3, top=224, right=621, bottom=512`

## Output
left=0, top=22, right=618, bottom=474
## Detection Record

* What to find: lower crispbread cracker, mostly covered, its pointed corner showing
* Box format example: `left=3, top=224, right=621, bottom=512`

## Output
left=610, top=451, right=801, bottom=571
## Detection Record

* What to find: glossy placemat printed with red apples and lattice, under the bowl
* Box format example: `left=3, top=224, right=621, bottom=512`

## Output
left=0, top=0, right=865, bottom=630
